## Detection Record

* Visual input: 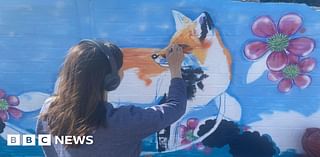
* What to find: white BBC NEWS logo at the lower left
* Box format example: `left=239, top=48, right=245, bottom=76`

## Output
left=7, top=134, right=93, bottom=146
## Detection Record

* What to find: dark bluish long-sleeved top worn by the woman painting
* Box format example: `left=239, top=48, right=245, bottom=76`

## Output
left=36, top=78, right=187, bottom=157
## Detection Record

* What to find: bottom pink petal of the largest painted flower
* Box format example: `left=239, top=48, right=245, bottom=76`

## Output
left=267, top=52, right=288, bottom=71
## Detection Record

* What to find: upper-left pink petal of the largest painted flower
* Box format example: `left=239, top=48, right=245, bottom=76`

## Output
left=251, top=16, right=277, bottom=37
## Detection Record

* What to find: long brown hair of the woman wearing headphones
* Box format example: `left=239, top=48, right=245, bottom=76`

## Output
left=40, top=42, right=122, bottom=147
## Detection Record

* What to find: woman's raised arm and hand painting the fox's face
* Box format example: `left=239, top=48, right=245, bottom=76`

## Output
left=114, top=45, right=187, bottom=138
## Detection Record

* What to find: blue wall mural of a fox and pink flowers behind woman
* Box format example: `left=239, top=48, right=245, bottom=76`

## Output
left=0, top=0, right=320, bottom=157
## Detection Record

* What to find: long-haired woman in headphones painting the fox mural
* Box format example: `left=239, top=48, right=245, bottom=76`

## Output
left=36, top=40, right=187, bottom=157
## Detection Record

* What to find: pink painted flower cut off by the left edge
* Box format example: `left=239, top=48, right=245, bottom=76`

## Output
left=0, top=89, right=22, bottom=121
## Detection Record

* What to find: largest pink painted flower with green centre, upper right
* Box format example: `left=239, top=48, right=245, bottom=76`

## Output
left=244, top=13, right=315, bottom=71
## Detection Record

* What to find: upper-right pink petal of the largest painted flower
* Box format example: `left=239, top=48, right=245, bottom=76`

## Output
left=278, top=13, right=302, bottom=35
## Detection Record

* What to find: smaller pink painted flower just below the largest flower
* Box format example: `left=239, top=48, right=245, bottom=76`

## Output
left=268, top=54, right=316, bottom=92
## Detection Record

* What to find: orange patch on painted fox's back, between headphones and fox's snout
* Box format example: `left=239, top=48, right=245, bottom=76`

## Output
left=121, top=48, right=167, bottom=86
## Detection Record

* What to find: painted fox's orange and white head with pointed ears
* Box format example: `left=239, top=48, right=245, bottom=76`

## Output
left=151, top=11, right=213, bottom=66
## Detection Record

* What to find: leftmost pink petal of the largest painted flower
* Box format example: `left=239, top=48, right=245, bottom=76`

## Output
left=244, top=41, right=268, bottom=60
